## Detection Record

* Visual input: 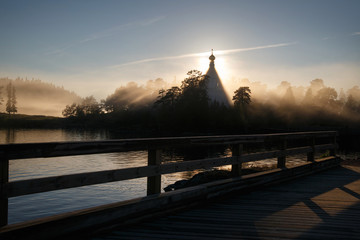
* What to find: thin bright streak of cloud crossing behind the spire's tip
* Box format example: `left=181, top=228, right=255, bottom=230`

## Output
left=110, top=42, right=297, bottom=68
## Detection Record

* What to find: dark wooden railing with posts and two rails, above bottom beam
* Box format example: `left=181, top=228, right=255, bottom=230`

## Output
left=0, top=131, right=337, bottom=227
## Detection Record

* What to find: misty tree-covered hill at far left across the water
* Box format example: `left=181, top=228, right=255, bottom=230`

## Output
left=0, top=78, right=81, bottom=116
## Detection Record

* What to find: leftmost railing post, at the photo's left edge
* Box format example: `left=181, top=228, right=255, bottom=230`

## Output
left=0, top=153, right=9, bottom=227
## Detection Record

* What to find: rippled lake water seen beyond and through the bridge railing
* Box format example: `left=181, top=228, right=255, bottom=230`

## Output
left=0, top=129, right=310, bottom=224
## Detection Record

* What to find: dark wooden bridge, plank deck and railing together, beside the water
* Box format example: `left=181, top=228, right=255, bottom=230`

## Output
left=0, top=131, right=360, bottom=239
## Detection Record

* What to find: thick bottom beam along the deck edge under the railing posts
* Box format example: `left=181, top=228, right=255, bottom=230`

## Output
left=0, top=157, right=339, bottom=240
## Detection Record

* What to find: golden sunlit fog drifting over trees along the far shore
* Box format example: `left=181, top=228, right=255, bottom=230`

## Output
left=0, top=75, right=360, bottom=127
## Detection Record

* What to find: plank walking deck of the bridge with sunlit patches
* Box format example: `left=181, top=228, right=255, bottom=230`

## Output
left=91, top=166, right=360, bottom=240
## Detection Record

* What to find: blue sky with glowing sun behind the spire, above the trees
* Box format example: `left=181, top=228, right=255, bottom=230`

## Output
left=0, top=0, right=360, bottom=100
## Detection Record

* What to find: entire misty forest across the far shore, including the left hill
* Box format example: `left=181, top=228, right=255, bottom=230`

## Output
left=0, top=70, right=360, bottom=136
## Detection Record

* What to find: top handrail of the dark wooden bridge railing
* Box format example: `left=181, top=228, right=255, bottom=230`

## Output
left=0, top=131, right=337, bottom=160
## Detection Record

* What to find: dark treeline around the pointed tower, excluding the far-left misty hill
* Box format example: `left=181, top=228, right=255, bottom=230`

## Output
left=63, top=70, right=360, bottom=135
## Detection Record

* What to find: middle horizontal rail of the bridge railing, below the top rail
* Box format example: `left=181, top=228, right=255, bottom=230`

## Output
left=6, top=147, right=338, bottom=197
